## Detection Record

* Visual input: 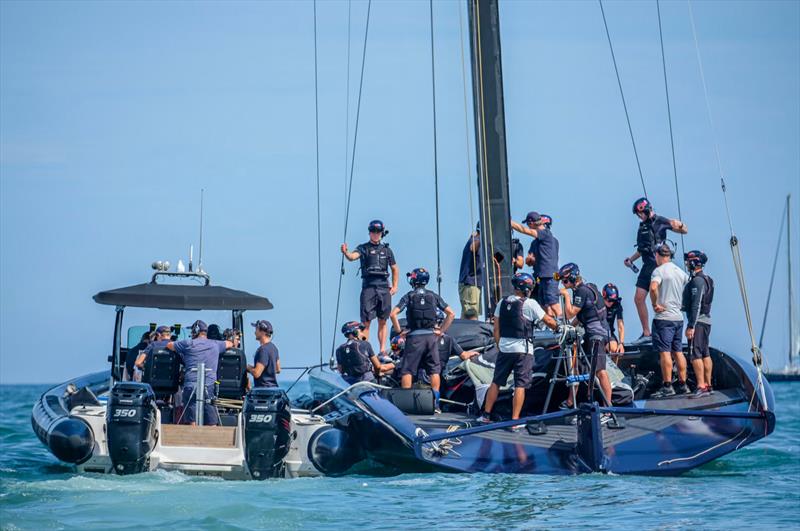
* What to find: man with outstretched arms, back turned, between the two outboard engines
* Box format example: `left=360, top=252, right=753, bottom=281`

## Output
left=166, top=319, right=233, bottom=426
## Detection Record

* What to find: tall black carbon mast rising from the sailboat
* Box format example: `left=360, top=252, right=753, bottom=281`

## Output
left=467, top=0, right=513, bottom=317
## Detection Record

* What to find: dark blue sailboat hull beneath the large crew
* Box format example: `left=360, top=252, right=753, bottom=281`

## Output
left=311, top=351, right=775, bottom=475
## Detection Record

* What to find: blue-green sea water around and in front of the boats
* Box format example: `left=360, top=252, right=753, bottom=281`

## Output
left=0, top=383, right=800, bottom=530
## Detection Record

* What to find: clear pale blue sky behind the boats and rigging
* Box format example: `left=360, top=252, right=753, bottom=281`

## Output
left=0, top=0, right=800, bottom=383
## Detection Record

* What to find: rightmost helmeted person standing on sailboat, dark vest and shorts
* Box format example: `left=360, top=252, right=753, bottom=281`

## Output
left=683, top=251, right=714, bottom=398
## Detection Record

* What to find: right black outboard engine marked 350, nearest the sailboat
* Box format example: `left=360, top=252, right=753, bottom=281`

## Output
left=242, top=387, right=292, bottom=479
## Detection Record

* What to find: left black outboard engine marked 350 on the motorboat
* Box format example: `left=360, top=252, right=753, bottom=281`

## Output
left=106, top=382, right=156, bottom=475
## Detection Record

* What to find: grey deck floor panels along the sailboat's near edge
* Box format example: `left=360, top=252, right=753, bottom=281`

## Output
left=408, top=389, right=746, bottom=450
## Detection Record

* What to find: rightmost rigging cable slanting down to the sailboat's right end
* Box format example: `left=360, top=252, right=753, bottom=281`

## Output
left=686, top=0, right=767, bottom=409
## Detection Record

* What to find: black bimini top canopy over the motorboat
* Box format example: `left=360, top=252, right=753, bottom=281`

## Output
left=92, top=282, right=272, bottom=310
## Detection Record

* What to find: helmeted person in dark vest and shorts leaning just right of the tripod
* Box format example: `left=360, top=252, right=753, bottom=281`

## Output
left=558, top=263, right=611, bottom=406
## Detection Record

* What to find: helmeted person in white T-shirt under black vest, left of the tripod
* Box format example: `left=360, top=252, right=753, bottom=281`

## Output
left=478, top=273, right=558, bottom=431
